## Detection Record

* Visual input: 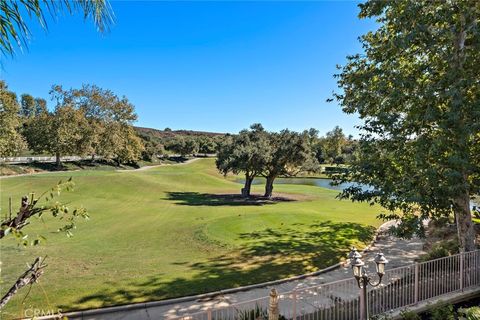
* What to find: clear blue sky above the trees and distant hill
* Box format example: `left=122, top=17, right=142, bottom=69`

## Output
left=1, top=1, right=375, bottom=134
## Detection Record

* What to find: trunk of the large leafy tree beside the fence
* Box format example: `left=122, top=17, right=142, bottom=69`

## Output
left=455, top=193, right=475, bottom=252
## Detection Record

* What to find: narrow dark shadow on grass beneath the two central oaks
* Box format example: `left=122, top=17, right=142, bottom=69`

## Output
left=164, top=192, right=296, bottom=206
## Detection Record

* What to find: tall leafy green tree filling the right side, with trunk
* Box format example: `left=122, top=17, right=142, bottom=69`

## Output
left=336, top=0, right=480, bottom=251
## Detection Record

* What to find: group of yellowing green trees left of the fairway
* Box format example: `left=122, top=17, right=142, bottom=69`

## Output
left=0, top=81, right=144, bottom=166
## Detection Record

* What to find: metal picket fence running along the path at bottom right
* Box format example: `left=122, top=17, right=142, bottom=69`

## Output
left=171, top=250, right=480, bottom=320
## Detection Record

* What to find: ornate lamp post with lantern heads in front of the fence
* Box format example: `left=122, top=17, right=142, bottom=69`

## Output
left=348, top=248, right=388, bottom=320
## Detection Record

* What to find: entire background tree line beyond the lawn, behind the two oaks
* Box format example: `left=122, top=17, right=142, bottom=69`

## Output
left=0, top=81, right=357, bottom=172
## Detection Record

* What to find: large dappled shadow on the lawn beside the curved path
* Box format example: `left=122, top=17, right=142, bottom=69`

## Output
left=69, top=221, right=375, bottom=309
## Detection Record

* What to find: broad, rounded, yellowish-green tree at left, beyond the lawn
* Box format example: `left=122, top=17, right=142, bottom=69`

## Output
left=22, top=85, right=144, bottom=165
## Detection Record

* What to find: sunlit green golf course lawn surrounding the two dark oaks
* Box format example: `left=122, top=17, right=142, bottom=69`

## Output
left=0, top=159, right=380, bottom=317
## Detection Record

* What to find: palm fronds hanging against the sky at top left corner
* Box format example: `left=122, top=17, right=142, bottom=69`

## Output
left=0, top=0, right=114, bottom=56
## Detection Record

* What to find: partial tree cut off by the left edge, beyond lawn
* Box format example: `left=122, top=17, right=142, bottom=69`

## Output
left=0, top=81, right=26, bottom=157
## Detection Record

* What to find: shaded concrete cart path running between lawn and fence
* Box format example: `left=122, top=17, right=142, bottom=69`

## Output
left=67, top=222, right=424, bottom=320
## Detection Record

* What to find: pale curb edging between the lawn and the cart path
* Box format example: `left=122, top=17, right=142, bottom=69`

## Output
left=36, top=221, right=392, bottom=320
